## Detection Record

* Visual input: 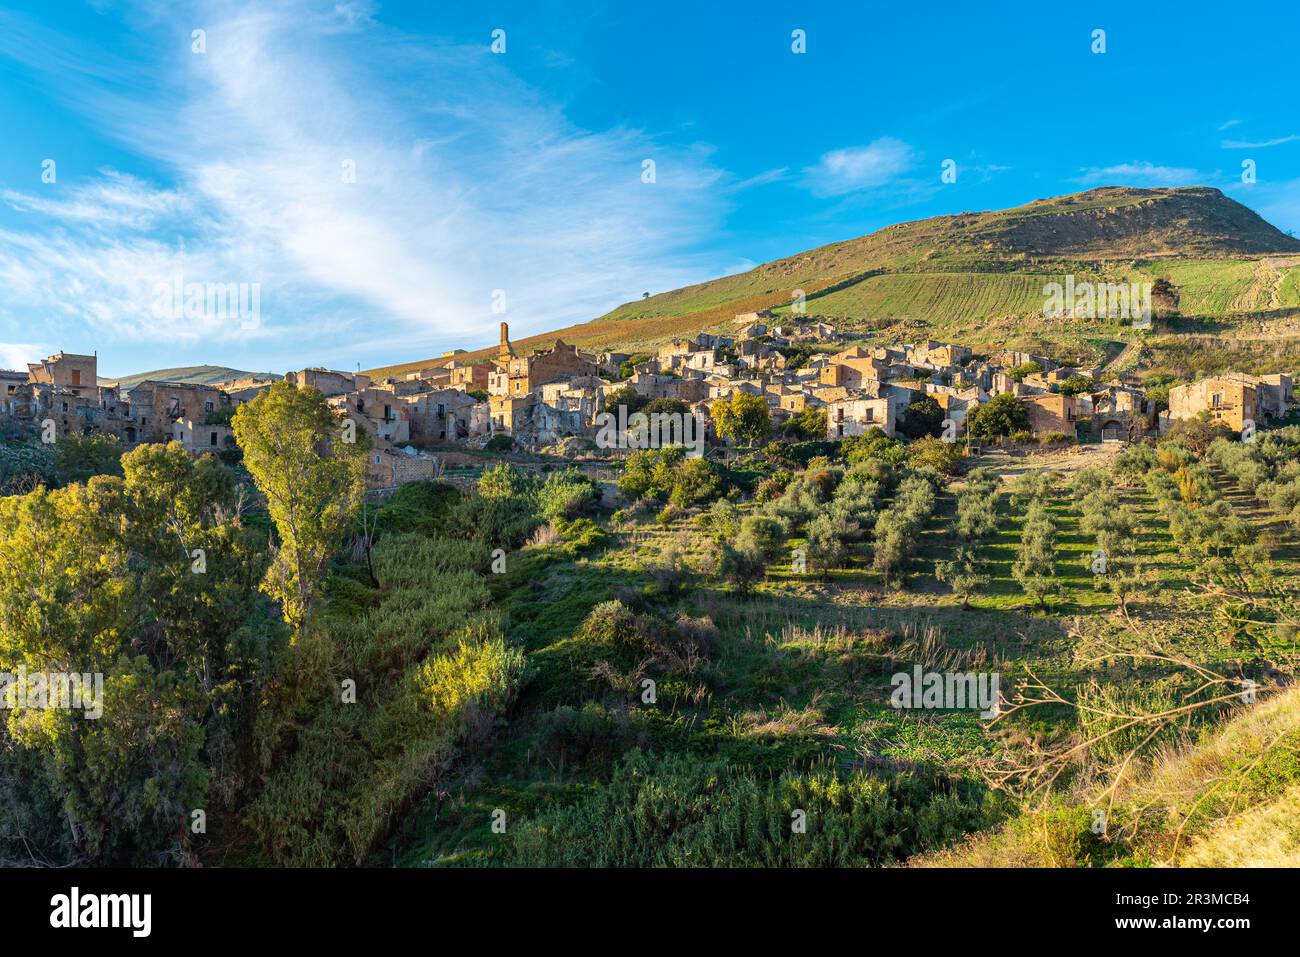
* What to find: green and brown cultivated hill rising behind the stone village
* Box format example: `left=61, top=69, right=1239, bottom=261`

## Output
left=372, top=187, right=1300, bottom=374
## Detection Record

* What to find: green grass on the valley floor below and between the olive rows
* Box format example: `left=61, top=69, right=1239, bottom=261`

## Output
left=377, top=444, right=1300, bottom=866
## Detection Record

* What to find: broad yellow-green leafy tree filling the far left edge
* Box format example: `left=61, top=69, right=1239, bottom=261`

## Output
left=0, top=443, right=269, bottom=865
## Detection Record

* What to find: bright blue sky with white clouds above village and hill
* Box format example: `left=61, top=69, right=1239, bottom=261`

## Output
left=0, top=0, right=1300, bottom=374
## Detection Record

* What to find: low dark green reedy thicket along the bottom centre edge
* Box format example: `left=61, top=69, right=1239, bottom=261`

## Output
left=494, top=752, right=1002, bottom=867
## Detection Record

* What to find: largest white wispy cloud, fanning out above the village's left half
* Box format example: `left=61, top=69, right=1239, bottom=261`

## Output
left=0, top=3, right=738, bottom=365
